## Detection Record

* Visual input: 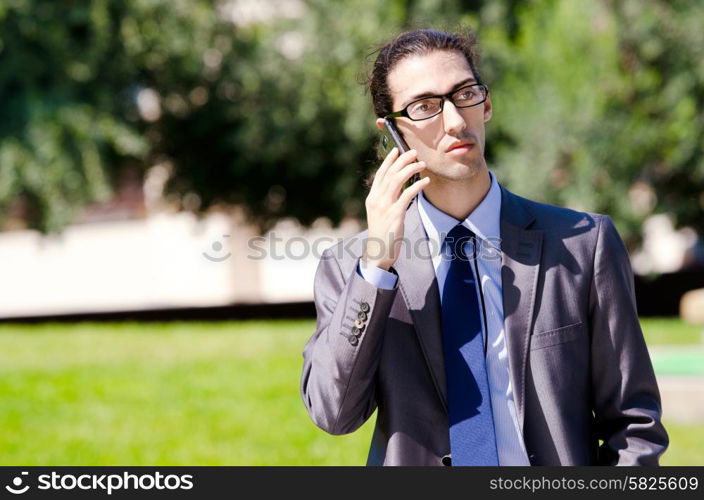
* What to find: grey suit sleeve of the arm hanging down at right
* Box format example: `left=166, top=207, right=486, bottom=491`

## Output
left=590, top=216, right=668, bottom=465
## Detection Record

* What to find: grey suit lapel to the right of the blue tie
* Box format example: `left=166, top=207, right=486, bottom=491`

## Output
left=501, top=187, right=543, bottom=430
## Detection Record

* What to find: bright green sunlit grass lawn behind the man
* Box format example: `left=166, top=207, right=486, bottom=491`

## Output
left=0, top=321, right=704, bottom=465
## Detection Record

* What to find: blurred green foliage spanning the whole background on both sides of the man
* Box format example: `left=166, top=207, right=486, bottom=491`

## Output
left=0, top=0, right=704, bottom=246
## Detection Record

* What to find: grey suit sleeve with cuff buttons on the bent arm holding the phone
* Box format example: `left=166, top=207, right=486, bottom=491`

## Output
left=301, top=249, right=398, bottom=434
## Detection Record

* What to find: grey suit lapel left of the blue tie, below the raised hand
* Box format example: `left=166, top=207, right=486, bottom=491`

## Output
left=394, top=198, right=447, bottom=411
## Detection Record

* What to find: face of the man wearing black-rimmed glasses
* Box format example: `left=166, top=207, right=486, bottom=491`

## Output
left=377, top=50, right=491, bottom=181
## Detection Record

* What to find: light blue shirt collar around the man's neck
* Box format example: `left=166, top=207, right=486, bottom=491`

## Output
left=418, top=172, right=501, bottom=250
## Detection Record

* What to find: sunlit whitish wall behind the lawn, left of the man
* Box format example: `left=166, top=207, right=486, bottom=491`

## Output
left=0, top=212, right=360, bottom=318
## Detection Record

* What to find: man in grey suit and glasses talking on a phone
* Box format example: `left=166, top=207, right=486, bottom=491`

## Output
left=301, top=30, right=668, bottom=465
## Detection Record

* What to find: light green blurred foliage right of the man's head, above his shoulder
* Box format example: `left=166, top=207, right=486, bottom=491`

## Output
left=482, top=0, right=704, bottom=246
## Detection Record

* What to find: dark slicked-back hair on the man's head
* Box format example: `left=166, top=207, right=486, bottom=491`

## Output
left=367, top=28, right=482, bottom=117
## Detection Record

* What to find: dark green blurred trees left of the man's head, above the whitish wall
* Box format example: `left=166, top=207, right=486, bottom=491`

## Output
left=0, top=0, right=468, bottom=231
